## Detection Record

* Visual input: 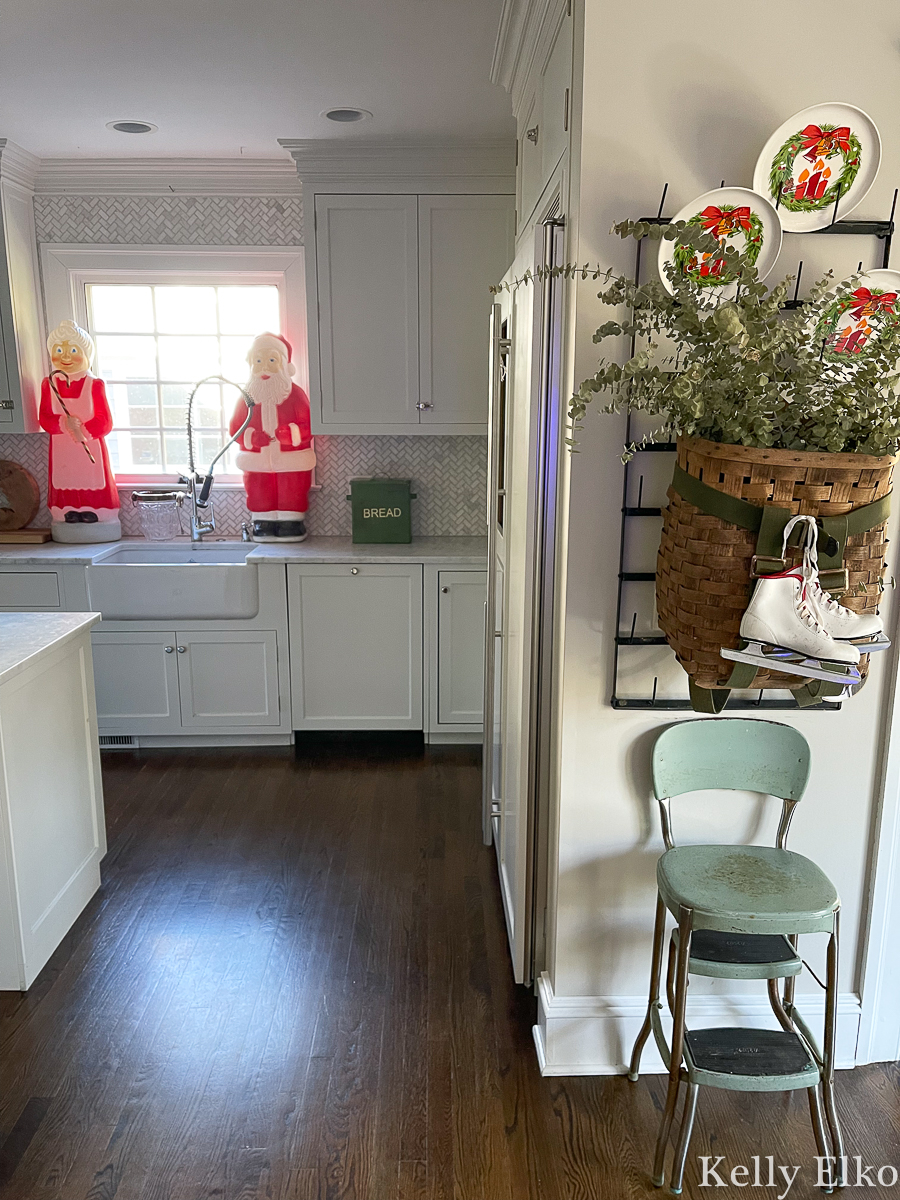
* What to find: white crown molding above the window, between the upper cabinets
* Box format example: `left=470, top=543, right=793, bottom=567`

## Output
left=29, top=156, right=300, bottom=196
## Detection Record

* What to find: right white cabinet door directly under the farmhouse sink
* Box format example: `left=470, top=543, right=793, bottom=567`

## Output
left=175, top=630, right=281, bottom=730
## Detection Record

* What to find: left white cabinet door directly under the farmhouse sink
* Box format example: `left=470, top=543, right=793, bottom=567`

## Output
left=91, top=632, right=181, bottom=734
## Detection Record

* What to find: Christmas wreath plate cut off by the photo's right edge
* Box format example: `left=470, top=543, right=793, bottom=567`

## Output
left=811, top=271, right=900, bottom=365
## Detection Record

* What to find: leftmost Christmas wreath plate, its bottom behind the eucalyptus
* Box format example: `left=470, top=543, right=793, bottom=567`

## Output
left=659, top=187, right=781, bottom=298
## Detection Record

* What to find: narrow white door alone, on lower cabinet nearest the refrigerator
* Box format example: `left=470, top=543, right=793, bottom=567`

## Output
left=438, top=571, right=487, bottom=725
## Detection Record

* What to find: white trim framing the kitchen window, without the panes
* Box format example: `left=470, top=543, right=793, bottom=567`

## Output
left=41, top=241, right=308, bottom=487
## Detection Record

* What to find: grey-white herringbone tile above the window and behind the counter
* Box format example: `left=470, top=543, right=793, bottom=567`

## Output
left=0, top=194, right=487, bottom=536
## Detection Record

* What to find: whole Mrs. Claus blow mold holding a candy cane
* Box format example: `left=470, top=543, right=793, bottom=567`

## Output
left=38, top=320, right=122, bottom=542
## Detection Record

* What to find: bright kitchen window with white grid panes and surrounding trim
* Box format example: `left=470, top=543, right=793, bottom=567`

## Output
left=41, top=244, right=307, bottom=484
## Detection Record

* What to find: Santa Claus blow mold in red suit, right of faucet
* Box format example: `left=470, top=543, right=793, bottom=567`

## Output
left=229, top=334, right=316, bottom=541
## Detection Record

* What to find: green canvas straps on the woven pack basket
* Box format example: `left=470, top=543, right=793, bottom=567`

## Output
left=672, top=463, right=890, bottom=713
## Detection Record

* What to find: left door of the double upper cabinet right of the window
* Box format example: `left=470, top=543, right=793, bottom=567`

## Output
left=313, top=196, right=422, bottom=432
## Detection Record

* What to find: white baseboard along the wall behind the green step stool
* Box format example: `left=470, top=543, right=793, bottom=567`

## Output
left=534, top=972, right=860, bottom=1075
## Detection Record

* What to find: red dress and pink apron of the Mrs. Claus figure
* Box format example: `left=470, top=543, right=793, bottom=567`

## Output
left=38, top=373, right=119, bottom=521
